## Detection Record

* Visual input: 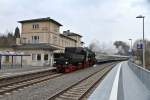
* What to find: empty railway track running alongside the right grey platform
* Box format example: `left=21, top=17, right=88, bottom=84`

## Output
left=49, top=64, right=115, bottom=100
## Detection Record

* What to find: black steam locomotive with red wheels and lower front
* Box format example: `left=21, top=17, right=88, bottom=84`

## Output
left=54, top=47, right=96, bottom=73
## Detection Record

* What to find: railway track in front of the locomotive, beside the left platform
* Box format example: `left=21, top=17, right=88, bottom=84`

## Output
left=0, top=72, right=62, bottom=95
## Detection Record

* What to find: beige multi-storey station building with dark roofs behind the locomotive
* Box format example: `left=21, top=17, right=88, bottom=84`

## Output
left=0, top=17, right=83, bottom=66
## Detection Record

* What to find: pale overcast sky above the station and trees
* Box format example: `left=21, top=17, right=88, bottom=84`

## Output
left=0, top=0, right=150, bottom=44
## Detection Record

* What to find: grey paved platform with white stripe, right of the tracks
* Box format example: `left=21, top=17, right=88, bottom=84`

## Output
left=88, top=61, right=150, bottom=100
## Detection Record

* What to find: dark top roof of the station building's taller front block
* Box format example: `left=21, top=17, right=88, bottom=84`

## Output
left=18, top=17, right=62, bottom=26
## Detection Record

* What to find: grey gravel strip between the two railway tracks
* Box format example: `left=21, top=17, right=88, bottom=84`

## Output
left=0, top=65, right=115, bottom=100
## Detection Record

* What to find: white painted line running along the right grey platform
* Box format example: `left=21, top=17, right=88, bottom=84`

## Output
left=109, top=63, right=122, bottom=100
